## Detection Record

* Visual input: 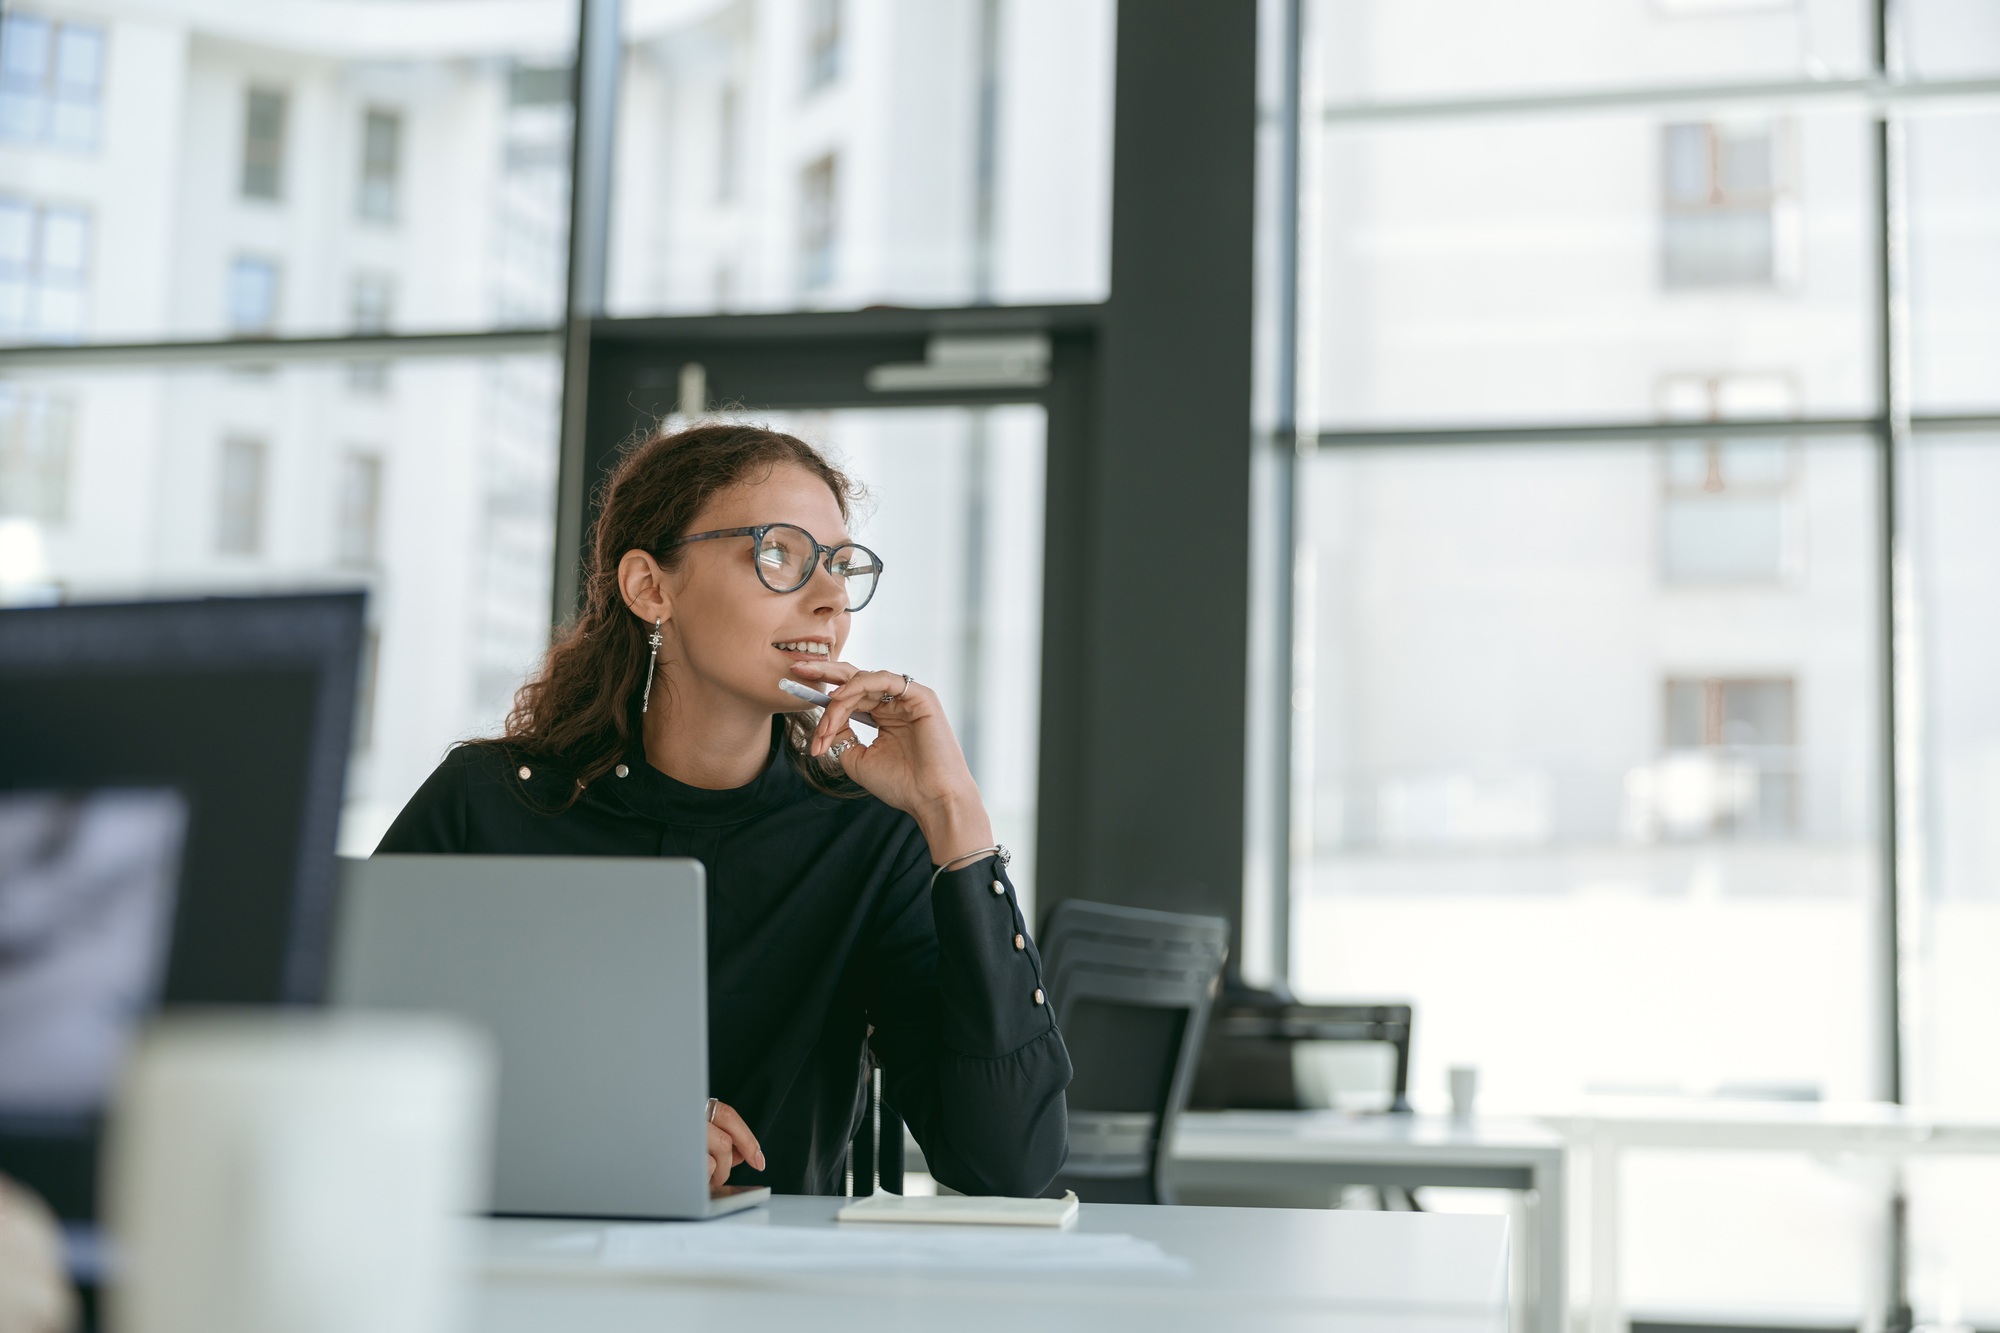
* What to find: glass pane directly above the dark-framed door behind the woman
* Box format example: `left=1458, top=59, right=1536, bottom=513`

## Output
left=608, top=0, right=1114, bottom=314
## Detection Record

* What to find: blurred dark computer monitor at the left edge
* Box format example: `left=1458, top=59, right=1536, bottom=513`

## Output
left=0, top=592, right=362, bottom=1219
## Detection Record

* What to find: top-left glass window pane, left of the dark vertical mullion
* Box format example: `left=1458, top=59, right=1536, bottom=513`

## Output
left=0, top=0, right=576, bottom=342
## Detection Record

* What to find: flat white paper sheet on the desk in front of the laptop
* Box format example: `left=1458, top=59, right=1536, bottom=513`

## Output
left=536, top=1223, right=1188, bottom=1273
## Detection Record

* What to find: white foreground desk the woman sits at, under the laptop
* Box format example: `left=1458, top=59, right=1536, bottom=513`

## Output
left=466, top=1197, right=1508, bottom=1333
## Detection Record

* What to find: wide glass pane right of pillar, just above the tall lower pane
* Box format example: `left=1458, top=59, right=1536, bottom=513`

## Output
left=1316, top=108, right=1876, bottom=428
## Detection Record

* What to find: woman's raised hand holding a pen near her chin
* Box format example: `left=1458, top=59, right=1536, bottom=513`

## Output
left=792, top=662, right=994, bottom=865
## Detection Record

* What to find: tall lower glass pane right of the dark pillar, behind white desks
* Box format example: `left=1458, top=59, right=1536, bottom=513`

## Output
left=1292, top=440, right=1882, bottom=1317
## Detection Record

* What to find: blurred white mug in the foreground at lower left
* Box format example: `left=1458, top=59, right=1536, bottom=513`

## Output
left=106, top=1013, right=494, bottom=1333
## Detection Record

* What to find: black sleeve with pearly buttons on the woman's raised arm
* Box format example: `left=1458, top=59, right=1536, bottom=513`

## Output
left=868, top=837, right=1070, bottom=1197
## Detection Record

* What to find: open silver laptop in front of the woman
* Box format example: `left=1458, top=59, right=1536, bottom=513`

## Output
left=332, top=857, right=770, bottom=1217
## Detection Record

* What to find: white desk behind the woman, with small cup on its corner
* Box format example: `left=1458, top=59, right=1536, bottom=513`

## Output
left=1172, top=1111, right=1568, bottom=1333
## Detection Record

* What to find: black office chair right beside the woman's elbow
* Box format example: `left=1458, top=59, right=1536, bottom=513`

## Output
left=1042, top=901, right=1230, bottom=1203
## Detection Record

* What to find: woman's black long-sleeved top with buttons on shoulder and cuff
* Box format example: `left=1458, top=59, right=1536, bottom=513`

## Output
left=376, top=719, right=1070, bottom=1195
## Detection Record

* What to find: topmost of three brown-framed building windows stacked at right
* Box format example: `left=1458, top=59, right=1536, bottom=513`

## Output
left=1660, top=120, right=1800, bottom=290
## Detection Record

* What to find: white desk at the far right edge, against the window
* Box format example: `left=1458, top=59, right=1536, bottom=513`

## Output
left=1546, top=1099, right=2000, bottom=1333
